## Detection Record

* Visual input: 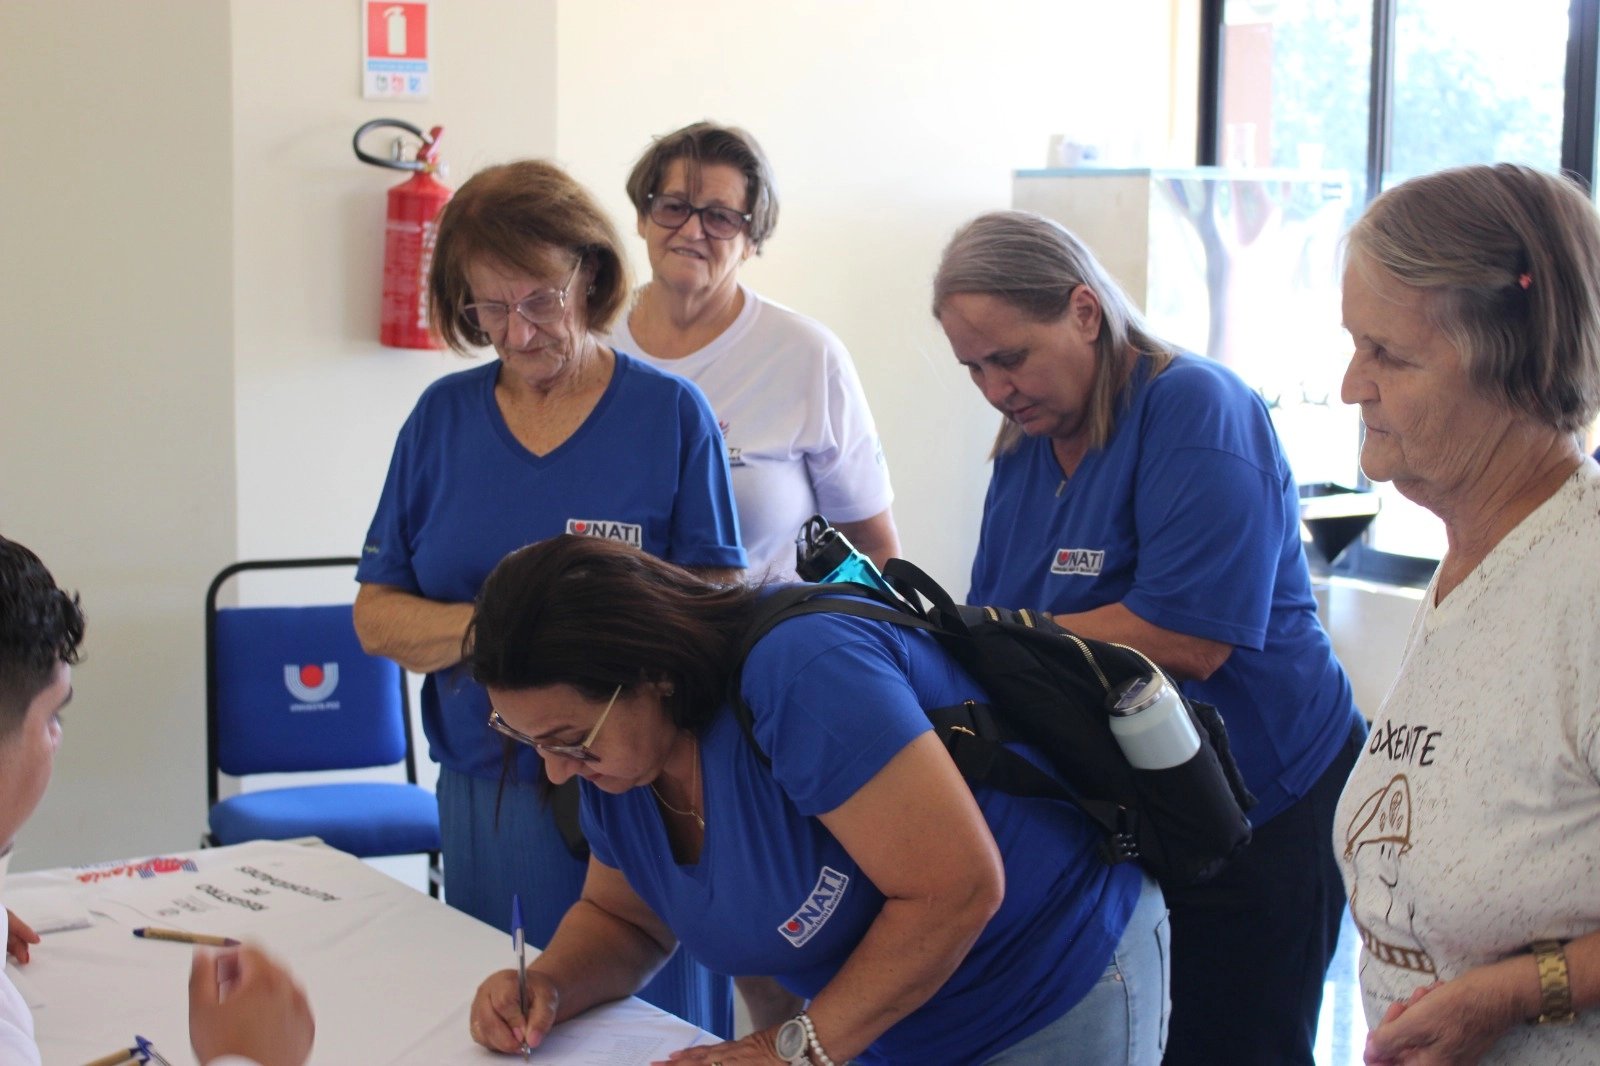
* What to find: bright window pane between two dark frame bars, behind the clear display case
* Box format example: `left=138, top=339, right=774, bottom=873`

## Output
left=1209, top=0, right=1373, bottom=485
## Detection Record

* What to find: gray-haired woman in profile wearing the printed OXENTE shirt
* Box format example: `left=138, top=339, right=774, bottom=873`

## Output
left=1334, top=163, right=1600, bottom=1066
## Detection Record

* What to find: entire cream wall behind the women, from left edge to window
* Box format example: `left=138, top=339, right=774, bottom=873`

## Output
left=12, top=0, right=1410, bottom=869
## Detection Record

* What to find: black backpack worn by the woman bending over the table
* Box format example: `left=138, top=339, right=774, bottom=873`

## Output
left=728, top=559, right=1256, bottom=888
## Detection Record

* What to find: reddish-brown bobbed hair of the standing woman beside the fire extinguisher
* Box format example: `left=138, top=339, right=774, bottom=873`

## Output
left=427, top=158, right=632, bottom=355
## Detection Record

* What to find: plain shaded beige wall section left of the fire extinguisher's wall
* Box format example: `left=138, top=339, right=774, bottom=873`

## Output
left=0, top=0, right=235, bottom=869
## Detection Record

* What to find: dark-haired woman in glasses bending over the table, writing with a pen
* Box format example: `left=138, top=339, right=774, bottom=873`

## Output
left=470, top=536, right=1168, bottom=1066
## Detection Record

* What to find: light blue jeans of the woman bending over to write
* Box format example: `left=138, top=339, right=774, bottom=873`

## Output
left=984, top=874, right=1171, bottom=1066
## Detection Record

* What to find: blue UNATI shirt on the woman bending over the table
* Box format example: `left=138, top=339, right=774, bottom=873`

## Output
left=582, top=615, right=1141, bottom=1064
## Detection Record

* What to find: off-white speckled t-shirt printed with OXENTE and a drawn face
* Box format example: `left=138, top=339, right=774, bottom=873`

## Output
left=1333, top=459, right=1600, bottom=1066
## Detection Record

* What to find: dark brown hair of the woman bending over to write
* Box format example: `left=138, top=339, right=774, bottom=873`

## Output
left=467, top=535, right=760, bottom=731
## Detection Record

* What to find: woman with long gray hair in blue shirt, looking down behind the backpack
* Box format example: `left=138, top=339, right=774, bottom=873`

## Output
left=933, top=211, right=1366, bottom=1066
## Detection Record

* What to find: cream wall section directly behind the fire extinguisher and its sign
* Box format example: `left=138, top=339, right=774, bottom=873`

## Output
left=232, top=0, right=555, bottom=573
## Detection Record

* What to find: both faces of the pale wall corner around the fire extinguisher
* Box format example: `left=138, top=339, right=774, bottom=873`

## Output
left=0, top=0, right=555, bottom=869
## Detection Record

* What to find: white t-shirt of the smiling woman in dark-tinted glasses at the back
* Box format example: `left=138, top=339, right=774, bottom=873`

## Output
left=605, top=285, right=894, bottom=581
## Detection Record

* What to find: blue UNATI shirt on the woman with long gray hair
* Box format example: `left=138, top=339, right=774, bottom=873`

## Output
left=968, top=355, right=1358, bottom=826
